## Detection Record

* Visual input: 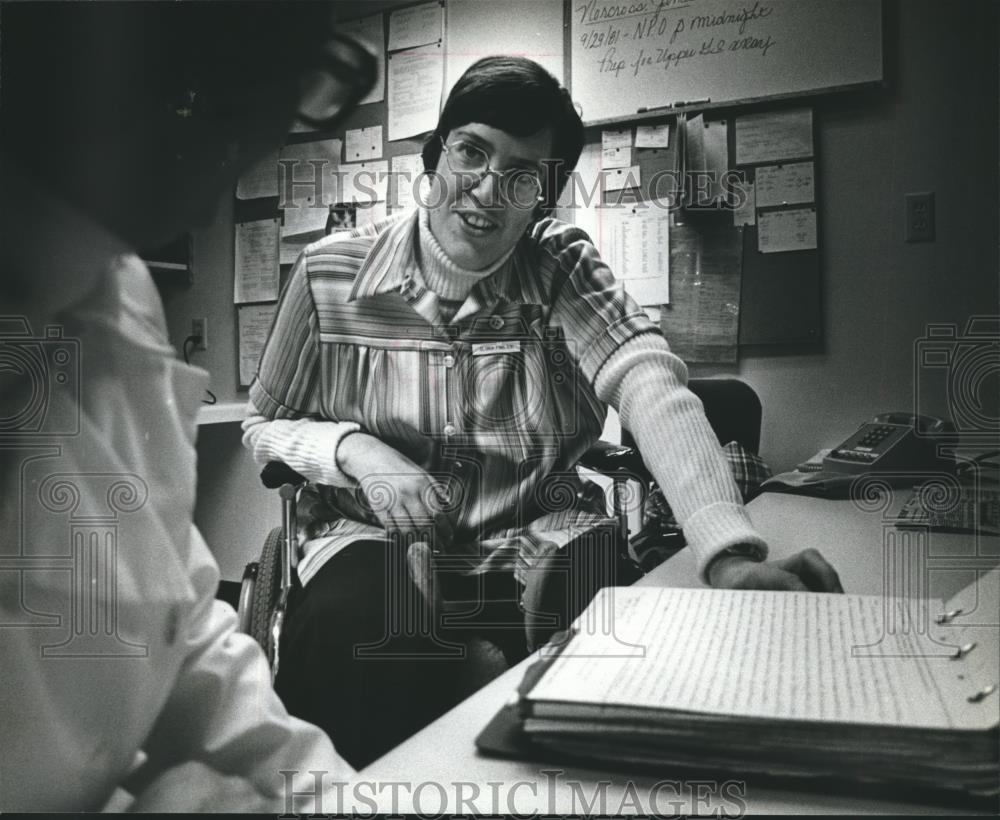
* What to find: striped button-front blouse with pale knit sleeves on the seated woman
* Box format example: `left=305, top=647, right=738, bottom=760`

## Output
left=244, top=208, right=763, bottom=583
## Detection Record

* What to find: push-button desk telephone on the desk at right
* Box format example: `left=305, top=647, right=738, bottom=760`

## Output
left=823, top=413, right=955, bottom=475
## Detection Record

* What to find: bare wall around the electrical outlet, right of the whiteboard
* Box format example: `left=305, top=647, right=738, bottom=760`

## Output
left=739, top=0, right=1000, bottom=468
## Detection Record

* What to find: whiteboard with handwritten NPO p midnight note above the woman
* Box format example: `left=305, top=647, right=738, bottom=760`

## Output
left=568, top=0, right=882, bottom=122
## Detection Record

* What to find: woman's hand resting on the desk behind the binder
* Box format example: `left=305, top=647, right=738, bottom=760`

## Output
left=708, top=549, right=844, bottom=592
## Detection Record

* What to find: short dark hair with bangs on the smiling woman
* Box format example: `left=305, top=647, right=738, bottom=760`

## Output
left=422, top=57, right=583, bottom=212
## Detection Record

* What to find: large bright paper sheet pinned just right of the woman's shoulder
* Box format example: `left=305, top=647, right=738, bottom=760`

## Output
left=600, top=206, right=670, bottom=305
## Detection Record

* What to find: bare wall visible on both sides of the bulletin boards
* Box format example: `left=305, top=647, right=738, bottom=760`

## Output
left=165, top=0, right=1000, bottom=578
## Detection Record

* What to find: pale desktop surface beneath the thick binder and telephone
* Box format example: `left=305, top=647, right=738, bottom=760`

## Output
left=359, top=494, right=1000, bottom=816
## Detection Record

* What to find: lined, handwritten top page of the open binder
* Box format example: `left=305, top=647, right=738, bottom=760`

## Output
left=530, top=587, right=996, bottom=728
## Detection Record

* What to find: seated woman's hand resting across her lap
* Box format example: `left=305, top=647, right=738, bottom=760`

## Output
left=337, top=433, right=452, bottom=549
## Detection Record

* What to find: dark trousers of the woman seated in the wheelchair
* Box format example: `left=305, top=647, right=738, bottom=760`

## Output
left=275, top=537, right=625, bottom=768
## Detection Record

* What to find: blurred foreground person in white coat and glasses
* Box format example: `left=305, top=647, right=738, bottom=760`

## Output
left=0, top=3, right=374, bottom=811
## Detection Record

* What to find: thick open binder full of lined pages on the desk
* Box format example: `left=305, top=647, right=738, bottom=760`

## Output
left=484, top=570, right=1000, bottom=795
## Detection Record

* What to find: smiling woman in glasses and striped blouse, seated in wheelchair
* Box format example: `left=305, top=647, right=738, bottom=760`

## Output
left=244, top=57, right=839, bottom=766
